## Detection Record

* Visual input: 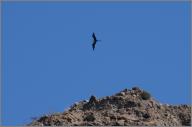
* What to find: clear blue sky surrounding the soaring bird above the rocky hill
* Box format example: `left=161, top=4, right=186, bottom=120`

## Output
left=2, top=2, right=190, bottom=125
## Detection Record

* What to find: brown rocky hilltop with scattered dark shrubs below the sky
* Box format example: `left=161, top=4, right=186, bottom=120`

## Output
left=28, top=87, right=191, bottom=126
